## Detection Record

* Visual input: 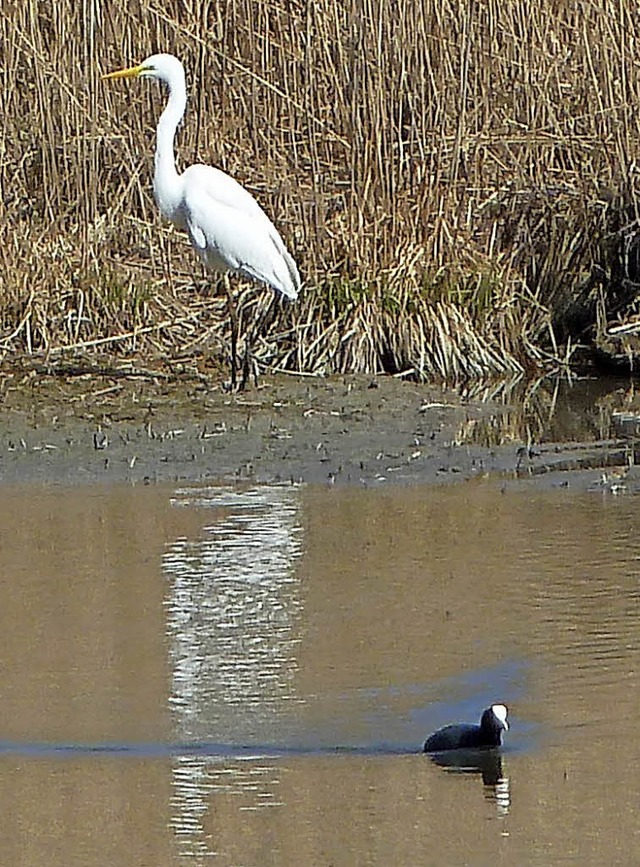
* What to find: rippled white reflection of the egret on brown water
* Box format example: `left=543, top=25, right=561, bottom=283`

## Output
left=163, top=486, right=302, bottom=857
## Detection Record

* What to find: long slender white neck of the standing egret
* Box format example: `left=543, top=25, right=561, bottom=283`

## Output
left=153, top=79, right=187, bottom=222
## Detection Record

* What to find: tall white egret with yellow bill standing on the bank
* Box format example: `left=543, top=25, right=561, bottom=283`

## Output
left=102, top=54, right=300, bottom=386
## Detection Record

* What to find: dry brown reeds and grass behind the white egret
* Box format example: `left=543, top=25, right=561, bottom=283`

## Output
left=0, top=0, right=640, bottom=381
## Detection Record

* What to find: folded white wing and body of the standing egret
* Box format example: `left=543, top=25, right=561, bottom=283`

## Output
left=183, top=166, right=300, bottom=300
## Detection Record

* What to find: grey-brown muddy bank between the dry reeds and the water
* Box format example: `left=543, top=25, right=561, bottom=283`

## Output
left=0, top=375, right=637, bottom=493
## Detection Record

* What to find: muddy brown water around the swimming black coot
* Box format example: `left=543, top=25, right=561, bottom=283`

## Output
left=0, top=481, right=640, bottom=867
